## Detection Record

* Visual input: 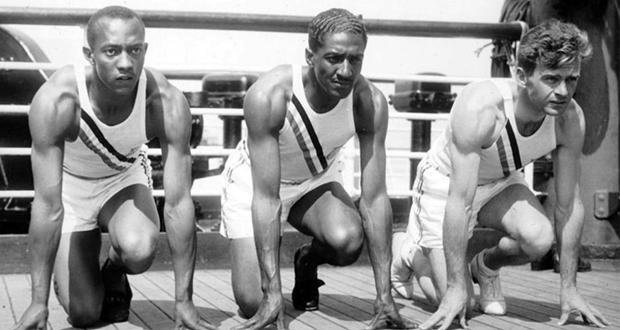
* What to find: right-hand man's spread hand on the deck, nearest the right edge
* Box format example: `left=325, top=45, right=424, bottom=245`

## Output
left=558, top=287, right=609, bottom=328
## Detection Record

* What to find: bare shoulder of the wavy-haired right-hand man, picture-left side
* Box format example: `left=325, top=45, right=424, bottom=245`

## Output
left=450, top=81, right=505, bottom=148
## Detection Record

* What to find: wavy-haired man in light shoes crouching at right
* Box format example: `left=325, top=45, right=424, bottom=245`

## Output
left=392, top=20, right=608, bottom=329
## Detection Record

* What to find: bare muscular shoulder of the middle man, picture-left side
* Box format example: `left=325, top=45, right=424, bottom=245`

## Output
left=243, top=65, right=293, bottom=129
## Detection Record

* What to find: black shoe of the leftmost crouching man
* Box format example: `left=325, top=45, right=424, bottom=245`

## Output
left=101, top=259, right=133, bottom=323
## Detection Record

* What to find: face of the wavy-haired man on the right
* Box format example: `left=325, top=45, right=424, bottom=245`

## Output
left=525, top=60, right=581, bottom=116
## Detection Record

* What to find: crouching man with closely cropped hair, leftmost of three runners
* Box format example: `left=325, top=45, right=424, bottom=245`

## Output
left=15, top=6, right=213, bottom=329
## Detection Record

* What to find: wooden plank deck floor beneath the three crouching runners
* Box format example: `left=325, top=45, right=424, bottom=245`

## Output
left=0, top=260, right=620, bottom=330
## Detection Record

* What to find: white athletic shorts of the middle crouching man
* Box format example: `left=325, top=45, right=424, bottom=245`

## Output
left=220, top=144, right=344, bottom=239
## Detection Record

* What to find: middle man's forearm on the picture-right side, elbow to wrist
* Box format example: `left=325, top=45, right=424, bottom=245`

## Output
left=359, top=196, right=392, bottom=300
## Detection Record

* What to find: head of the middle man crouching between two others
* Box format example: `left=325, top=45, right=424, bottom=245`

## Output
left=306, top=8, right=368, bottom=98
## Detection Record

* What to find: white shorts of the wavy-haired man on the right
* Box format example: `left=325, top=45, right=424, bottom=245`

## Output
left=407, top=159, right=527, bottom=249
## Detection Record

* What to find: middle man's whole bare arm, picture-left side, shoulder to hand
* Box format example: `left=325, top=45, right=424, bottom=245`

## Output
left=234, top=69, right=291, bottom=329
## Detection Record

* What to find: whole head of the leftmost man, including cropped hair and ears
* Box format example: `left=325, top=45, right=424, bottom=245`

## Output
left=83, top=6, right=147, bottom=94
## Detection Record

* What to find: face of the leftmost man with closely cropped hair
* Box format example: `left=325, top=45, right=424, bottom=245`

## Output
left=85, top=18, right=147, bottom=95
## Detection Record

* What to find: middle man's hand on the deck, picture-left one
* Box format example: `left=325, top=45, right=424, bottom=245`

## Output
left=232, top=293, right=286, bottom=330
